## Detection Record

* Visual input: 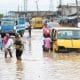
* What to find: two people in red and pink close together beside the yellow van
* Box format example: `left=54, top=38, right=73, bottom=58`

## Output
left=43, top=20, right=53, bottom=52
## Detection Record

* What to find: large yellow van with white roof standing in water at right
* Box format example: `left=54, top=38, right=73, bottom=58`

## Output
left=51, top=27, right=80, bottom=52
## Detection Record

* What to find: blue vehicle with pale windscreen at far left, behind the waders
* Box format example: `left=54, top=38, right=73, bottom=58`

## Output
left=0, top=18, right=16, bottom=37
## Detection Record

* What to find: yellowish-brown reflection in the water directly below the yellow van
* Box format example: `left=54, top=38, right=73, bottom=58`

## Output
left=53, top=52, right=80, bottom=61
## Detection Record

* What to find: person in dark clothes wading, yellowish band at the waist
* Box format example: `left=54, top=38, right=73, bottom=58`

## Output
left=14, top=34, right=24, bottom=60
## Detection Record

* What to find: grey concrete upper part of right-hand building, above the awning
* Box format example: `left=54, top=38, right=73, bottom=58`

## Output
left=58, top=5, right=80, bottom=16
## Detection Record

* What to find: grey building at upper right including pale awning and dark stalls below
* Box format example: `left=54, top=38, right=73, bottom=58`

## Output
left=58, top=4, right=80, bottom=26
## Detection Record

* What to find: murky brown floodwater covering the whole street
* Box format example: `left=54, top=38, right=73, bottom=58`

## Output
left=0, top=29, right=80, bottom=80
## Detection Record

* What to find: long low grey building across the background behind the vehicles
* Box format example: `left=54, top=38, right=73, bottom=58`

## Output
left=8, top=11, right=57, bottom=18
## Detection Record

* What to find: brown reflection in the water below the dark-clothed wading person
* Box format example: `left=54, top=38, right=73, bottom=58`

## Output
left=16, top=61, right=24, bottom=80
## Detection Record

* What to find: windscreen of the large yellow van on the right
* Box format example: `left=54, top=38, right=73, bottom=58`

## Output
left=58, top=30, right=80, bottom=39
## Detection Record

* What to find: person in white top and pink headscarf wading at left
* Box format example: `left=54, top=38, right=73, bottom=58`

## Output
left=3, top=33, right=13, bottom=58
